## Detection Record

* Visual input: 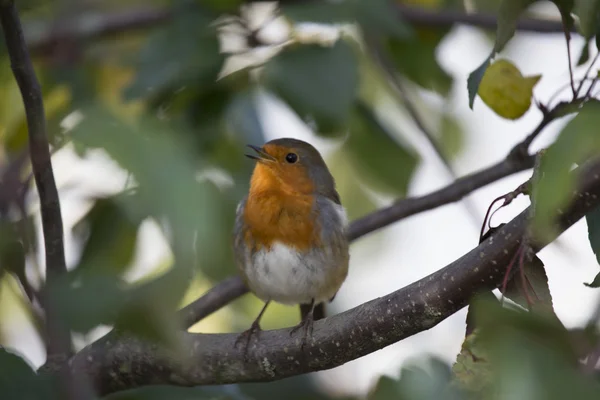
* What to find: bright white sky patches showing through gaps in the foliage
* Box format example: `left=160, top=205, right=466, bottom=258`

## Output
left=1, top=2, right=600, bottom=393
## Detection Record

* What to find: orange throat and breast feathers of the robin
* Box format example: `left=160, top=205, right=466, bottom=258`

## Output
left=244, top=164, right=321, bottom=251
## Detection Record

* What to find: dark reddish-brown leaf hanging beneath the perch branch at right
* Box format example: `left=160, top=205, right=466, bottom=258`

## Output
left=504, top=255, right=556, bottom=316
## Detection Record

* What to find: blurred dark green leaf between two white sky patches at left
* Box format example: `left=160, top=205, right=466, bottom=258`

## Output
left=74, top=195, right=145, bottom=275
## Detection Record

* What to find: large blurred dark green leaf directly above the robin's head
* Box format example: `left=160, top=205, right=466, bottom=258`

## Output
left=264, top=40, right=358, bottom=133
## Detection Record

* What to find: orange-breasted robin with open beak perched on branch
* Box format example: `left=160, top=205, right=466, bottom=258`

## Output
left=233, top=139, right=350, bottom=350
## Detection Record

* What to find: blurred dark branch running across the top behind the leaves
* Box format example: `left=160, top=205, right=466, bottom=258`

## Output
left=21, top=5, right=576, bottom=52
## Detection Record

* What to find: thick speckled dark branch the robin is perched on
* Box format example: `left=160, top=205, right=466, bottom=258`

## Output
left=70, top=158, right=600, bottom=394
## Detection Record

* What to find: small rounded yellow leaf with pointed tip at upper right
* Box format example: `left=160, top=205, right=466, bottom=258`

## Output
left=478, top=59, right=542, bottom=120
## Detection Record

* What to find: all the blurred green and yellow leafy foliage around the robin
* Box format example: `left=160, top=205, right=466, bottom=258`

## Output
left=0, top=0, right=600, bottom=400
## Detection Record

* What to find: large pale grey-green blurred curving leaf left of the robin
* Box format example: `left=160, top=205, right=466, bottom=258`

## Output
left=67, top=107, right=223, bottom=342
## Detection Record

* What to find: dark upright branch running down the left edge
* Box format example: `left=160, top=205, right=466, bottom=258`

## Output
left=0, top=0, right=71, bottom=356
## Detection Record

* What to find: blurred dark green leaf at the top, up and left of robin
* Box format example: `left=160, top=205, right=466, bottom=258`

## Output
left=124, top=3, right=224, bottom=100
